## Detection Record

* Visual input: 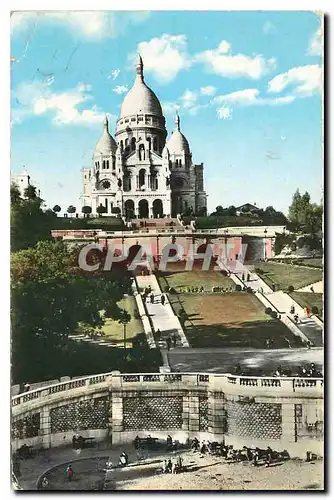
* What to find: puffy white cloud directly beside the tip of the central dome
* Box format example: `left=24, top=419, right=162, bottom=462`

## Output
left=134, top=34, right=191, bottom=83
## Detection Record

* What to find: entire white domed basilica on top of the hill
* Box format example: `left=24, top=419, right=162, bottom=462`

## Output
left=81, top=56, right=206, bottom=219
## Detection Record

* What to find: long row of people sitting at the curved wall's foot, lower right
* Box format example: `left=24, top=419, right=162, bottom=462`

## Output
left=191, top=438, right=289, bottom=467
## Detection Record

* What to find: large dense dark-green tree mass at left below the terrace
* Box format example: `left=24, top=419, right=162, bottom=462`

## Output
left=11, top=241, right=131, bottom=383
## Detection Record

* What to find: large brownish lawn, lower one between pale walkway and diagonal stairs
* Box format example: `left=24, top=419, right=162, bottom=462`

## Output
left=169, top=292, right=302, bottom=349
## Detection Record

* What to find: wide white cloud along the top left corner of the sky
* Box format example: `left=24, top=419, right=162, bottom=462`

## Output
left=11, top=11, right=150, bottom=41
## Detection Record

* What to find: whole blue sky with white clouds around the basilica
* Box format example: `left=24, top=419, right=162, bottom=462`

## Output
left=11, top=11, right=322, bottom=212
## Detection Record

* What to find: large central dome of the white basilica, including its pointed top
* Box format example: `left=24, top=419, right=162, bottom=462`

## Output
left=120, top=56, right=163, bottom=118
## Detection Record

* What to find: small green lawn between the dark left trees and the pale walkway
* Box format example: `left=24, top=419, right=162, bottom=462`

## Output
left=102, top=296, right=144, bottom=343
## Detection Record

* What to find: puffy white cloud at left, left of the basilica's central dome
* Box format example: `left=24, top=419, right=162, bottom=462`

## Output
left=12, top=82, right=113, bottom=125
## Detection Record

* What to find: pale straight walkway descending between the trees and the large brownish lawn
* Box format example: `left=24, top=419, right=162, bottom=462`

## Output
left=136, top=274, right=189, bottom=348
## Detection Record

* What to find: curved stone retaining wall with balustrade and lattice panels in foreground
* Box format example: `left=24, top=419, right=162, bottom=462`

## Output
left=12, top=372, right=323, bottom=457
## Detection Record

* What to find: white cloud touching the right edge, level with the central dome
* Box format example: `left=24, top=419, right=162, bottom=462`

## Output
left=268, top=64, right=322, bottom=97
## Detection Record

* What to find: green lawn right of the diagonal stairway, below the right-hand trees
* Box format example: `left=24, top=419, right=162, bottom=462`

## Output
left=256, top=262, right=322, bottom=290
